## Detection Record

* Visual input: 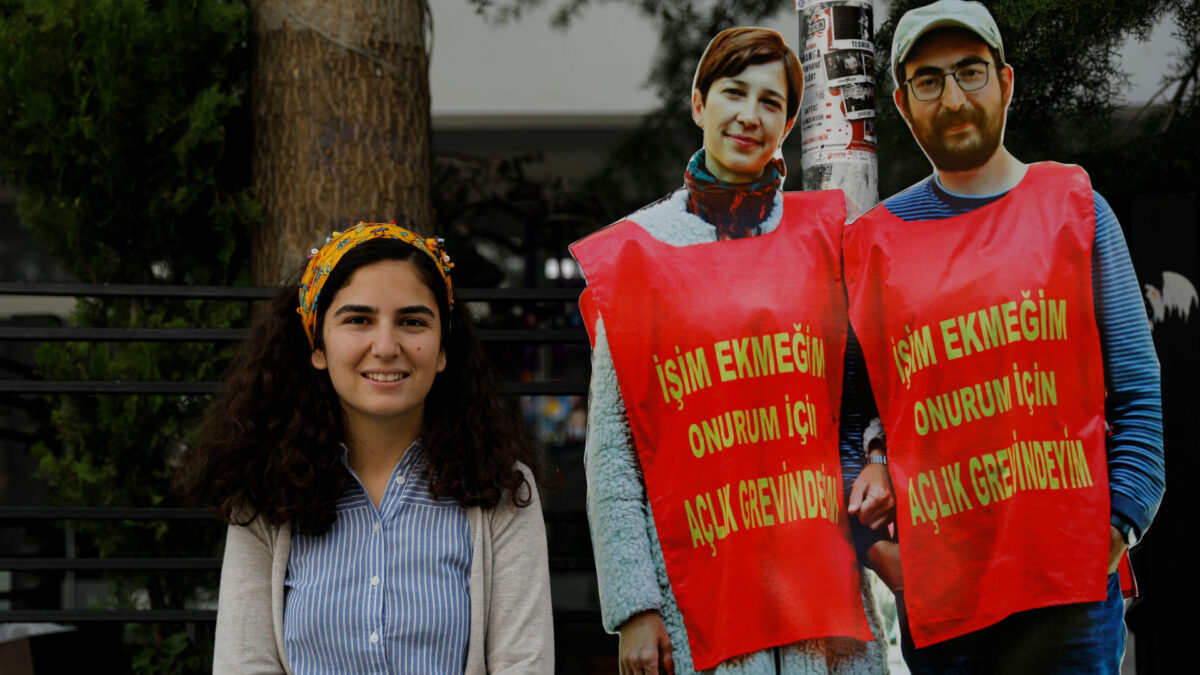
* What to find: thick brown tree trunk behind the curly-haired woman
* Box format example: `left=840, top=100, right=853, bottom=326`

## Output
left=252, top=0, right=433, bottom=285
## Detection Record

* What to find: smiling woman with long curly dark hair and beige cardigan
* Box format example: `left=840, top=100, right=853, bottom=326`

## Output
left=181, top=223, right=553, bottom=674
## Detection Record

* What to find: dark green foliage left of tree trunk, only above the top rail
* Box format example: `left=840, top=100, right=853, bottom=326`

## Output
left=0, top=0, right=258, bottom=283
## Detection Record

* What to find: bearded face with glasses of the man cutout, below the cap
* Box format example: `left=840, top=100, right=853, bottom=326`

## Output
left=895, top=30, right=1013, bottom=172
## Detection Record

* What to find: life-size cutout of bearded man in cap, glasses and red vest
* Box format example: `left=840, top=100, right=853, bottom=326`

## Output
left=844, top=0, right=1164, bottom=673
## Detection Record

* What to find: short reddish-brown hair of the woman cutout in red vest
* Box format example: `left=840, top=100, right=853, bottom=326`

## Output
left=691, top=28, right=804, bottom=121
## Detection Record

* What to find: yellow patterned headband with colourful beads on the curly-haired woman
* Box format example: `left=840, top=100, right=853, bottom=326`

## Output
left=296, top=221, right=454, bottom=346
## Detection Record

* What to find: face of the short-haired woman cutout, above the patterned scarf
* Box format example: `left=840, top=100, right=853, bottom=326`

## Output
left=691, top=61, right=796, bottom=183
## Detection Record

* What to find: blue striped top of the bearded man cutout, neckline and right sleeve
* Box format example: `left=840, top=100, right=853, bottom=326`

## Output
left=883, top=174, right=1165, bottom=534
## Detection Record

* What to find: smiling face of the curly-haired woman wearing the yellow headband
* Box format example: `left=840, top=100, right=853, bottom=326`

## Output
left=312, top=261, right=446, bottom=429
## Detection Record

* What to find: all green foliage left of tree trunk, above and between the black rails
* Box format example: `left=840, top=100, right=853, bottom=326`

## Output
left=0, top=0, right=260, bottom=673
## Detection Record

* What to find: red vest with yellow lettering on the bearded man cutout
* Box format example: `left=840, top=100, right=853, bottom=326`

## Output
left=844, top=163, right=1109, bottom=647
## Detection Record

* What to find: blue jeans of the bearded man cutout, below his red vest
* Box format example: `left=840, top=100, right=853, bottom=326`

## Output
left=896, top=574, right=1126, bottom=675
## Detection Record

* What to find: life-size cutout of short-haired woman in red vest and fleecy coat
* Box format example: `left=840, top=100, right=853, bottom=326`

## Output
left=572, top=28, right=892, bottom=674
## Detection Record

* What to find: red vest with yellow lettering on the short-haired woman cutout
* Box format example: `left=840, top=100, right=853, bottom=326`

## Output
left=571, top=192, right=871, bottom=669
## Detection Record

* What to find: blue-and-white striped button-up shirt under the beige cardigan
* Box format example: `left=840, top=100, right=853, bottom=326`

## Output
left=283, top=442, right=472, bottom=675
